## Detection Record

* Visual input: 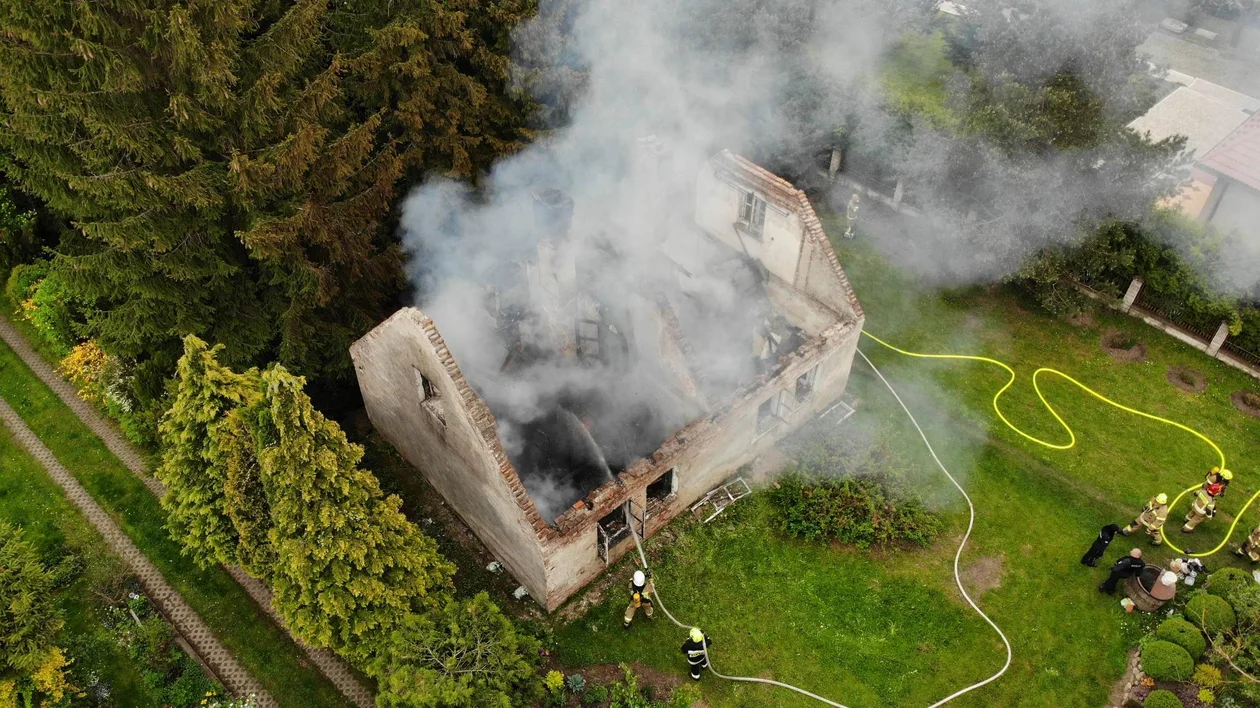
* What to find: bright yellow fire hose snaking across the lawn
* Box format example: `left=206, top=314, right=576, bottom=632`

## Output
left=862, top=330, right=1260, bottom=558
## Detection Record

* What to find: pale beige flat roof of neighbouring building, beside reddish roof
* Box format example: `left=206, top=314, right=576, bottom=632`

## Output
left=1129, top=78, right=1260, bottom=159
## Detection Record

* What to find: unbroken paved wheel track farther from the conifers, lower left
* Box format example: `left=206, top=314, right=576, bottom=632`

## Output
left=0, top=398, right=278, bottom=708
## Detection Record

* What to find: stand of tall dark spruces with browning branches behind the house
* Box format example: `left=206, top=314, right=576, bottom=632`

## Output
left=0, top=0, right=528, bottom=397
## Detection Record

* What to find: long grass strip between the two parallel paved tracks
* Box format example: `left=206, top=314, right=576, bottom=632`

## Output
left=0, top=332, right=344, bottom=708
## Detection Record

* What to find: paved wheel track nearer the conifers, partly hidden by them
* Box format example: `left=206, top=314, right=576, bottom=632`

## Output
left=0, top=316, right=375, bottom=708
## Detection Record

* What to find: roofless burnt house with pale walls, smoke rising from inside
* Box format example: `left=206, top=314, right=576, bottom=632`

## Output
left=352, top=142, right=863, bottom=611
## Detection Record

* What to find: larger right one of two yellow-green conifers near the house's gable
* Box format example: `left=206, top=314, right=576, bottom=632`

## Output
left=249, top=367, right=454, bottom=665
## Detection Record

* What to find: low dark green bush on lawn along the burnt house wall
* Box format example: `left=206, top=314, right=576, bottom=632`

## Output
left=770, top=470, right=944, bottom=548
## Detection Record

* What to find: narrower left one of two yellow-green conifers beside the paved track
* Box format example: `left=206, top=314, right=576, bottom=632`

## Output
left=155, top=335, right=261, bottom=566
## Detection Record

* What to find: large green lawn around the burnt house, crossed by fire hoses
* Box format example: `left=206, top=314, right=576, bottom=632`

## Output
left=557, top=231, right=1260, bottom=708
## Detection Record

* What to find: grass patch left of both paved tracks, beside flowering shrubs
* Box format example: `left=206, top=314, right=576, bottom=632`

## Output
left=0, top=426, right=156, bottom=707
